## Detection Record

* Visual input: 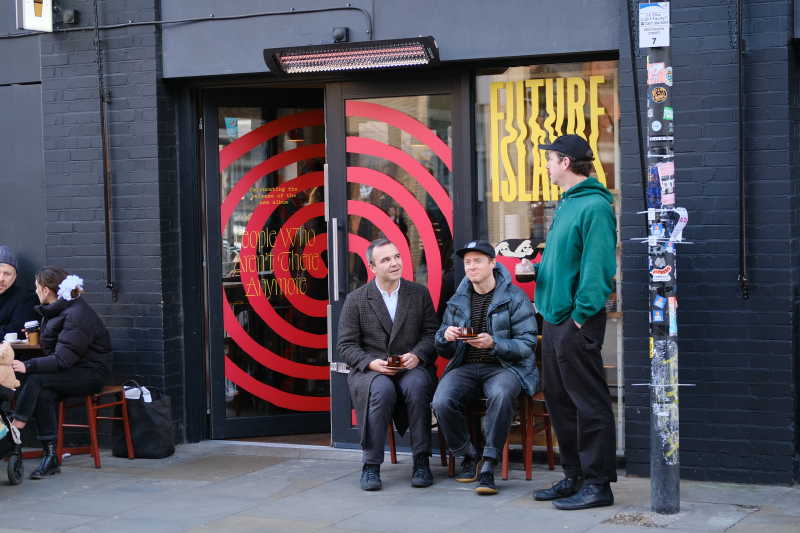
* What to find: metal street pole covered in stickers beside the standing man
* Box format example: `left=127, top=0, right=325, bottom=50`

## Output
left=639, top=2, right=687, bottom=514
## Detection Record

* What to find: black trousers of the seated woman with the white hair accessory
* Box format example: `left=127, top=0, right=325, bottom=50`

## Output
left=14, top=367, right=105, bottom=441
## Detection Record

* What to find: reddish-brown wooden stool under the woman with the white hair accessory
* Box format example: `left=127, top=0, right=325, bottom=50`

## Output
left=56, top=385, right=133, bottom=468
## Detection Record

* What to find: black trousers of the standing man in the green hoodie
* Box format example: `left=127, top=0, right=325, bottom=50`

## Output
left=542, top=311, right=617, bottom=483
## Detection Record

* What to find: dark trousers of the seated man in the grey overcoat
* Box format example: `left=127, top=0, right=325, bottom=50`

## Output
left=362, top=366, right=434, bottom=464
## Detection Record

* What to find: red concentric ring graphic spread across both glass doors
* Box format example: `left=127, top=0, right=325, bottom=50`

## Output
left=219, top=101, right=453, bottom=411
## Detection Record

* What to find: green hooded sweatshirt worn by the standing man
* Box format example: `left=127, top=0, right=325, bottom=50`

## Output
left=536, top=178, right=617, bottom=324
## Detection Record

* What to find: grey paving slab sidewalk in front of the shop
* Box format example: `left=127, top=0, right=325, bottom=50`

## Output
left=0, top=441, right=800, bottom=533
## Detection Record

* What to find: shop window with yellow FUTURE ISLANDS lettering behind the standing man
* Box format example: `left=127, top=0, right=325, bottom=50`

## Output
left=475, top=61, right=625, bottom=451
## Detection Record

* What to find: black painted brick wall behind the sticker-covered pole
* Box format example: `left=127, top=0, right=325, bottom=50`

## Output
left=620, top=0, right=800, bottom=483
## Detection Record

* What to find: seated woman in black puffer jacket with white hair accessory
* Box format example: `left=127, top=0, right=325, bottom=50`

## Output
left=12, top=267, right=111, bottom=479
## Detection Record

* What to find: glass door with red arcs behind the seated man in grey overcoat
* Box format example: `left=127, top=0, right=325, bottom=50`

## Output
left=326, top=77, right=470, bottom=445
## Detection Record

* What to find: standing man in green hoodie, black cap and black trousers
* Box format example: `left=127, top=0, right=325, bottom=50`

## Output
left=533, top=135, right=617, bottom=510
